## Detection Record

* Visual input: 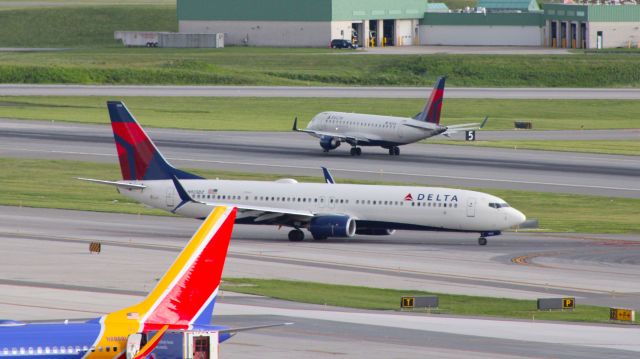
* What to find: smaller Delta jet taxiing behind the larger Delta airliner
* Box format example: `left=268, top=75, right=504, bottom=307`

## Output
left=293, top=77, right=487, bottom=156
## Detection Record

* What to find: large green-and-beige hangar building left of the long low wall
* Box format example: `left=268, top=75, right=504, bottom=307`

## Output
left=178, top=0, right=427, bottom=47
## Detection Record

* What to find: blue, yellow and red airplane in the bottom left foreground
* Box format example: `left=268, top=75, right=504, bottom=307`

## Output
left=0, top=206, right=289, bottom=359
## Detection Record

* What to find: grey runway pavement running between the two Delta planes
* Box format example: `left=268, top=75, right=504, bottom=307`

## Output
left=0, top=120, right=640, bottom=198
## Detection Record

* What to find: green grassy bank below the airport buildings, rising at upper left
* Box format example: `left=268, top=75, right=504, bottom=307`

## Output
left=0, top=6, right=640, bottom=87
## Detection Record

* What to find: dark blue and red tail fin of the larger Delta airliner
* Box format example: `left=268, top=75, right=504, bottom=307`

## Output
left=107, top=101, right=202, bottom=180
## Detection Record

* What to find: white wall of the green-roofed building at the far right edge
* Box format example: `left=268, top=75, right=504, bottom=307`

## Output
left=587, top=22, right=640, bottom=49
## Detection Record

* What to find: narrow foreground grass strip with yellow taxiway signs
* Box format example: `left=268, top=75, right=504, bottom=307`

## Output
left=222, top=278, right=609, bottom=322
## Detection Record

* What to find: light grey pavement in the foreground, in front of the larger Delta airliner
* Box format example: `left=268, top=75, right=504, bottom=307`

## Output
left=0, top=207, right=640, bottom=358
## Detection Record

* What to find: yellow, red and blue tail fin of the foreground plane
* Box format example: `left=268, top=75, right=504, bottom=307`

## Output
left=102, top=206, right=236, bottom=337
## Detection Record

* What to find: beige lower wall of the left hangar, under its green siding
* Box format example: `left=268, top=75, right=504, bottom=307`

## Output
left=179, top=20, right=330, bottom=47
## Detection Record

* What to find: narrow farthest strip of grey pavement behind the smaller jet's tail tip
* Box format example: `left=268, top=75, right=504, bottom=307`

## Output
left=0, top=84, right=640, bottom=100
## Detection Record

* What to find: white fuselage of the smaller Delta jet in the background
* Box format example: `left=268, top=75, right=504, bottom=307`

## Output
left=307, top=112, right=445, bottom=146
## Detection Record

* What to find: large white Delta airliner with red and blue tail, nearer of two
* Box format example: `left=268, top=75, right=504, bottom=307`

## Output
left=81, top=101, right=525, bottom=245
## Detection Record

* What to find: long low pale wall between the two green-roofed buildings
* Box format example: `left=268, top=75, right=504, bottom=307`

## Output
left=419, top=25, right=544, bottom=46
